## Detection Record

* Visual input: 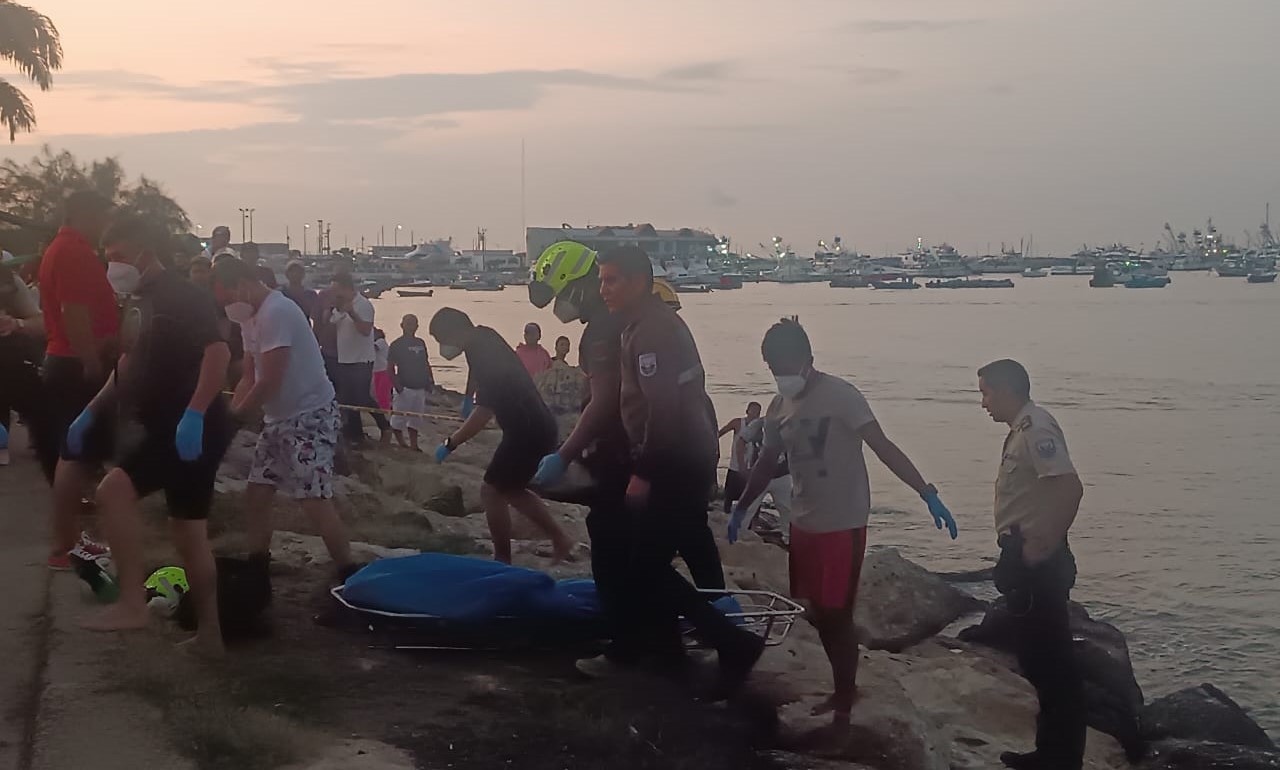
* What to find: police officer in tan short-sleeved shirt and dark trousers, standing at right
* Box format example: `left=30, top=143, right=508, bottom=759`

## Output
left=978, top=359, right=1085, bottom=770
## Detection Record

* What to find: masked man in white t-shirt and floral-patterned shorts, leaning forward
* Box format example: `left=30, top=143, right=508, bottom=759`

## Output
left=214, top=258, right=351, bottom=574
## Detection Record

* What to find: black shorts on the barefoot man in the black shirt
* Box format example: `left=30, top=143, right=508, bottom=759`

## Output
left=119, top=414, right=233, bottom=521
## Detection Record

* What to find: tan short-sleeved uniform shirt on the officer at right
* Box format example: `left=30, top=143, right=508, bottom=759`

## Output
left=996, top=402, right=1075, bottom=535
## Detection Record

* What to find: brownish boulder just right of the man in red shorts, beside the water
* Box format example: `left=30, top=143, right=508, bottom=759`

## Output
left=854, top=549, right=982, bottom=652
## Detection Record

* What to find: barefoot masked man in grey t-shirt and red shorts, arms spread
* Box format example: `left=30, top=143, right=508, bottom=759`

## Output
left=728, top=318, right=956, bottom=724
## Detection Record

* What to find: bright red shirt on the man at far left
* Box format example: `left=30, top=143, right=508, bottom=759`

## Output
left=40, top=226, right=120, bottom=357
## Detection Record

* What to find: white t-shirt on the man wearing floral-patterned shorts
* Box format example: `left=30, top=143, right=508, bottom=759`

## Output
left=241, top=292, right=334, bottom=422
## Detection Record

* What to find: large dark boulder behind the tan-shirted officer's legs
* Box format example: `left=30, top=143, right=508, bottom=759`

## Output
left=960, top=599, right=1146, bottom=761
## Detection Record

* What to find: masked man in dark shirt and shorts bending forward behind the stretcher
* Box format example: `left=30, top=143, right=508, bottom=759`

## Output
left=430, top=307, right=573, bottom=564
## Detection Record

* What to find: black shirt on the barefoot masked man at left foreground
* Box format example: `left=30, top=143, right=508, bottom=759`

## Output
left=118, top=270, right=225, bottom=430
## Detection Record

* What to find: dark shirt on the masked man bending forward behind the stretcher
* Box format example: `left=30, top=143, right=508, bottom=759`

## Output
left=466, top=326, right=557, bottom=436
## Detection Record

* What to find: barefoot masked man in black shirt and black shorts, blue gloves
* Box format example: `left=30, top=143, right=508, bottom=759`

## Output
left=67, top=219, right=232, bottom=655
